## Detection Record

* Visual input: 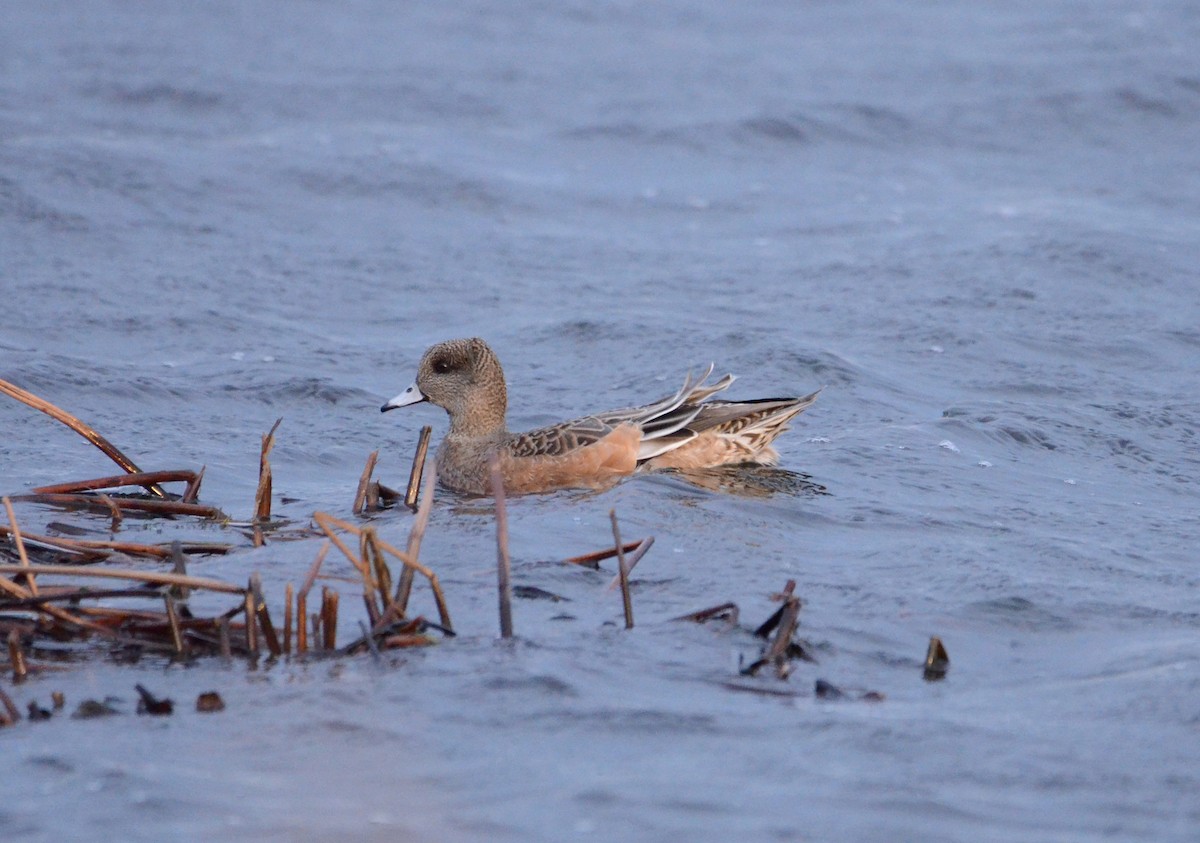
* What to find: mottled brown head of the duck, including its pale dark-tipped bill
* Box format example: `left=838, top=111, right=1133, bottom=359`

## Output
left=382, top=337, right=508, bottom=436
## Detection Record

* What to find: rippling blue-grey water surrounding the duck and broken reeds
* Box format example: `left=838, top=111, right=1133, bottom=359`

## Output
left=0, top=0, right=1200, bottom=841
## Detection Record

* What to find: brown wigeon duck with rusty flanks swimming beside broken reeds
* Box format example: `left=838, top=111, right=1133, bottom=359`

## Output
left=380, top=339, right=820, bottom=495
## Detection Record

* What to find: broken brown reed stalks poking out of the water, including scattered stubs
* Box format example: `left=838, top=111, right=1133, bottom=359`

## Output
left=0, top=381, right=902, bottom=725
